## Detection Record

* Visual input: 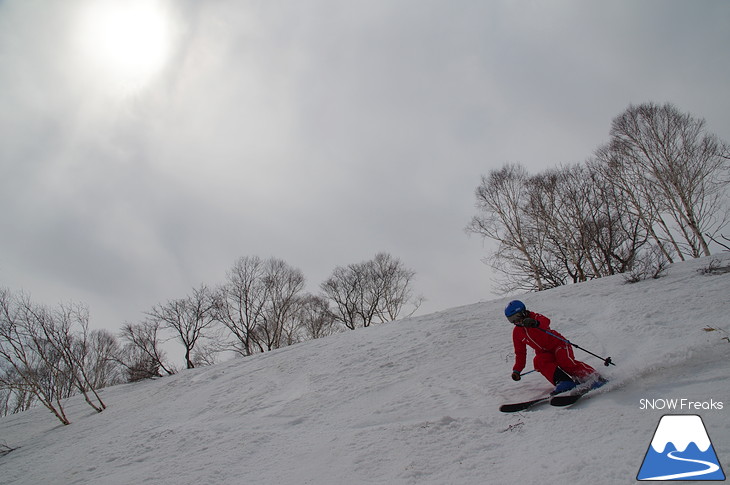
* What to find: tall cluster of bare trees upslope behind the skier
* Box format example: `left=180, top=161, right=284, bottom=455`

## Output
left=467, top=103, right=730, bottom=292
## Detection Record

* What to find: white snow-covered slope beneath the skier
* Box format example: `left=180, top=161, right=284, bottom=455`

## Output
left=0, top=253, right=730, bottom=485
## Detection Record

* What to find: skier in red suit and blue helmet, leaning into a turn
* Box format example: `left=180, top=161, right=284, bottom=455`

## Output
left=504, top=300, right=606, bottom=395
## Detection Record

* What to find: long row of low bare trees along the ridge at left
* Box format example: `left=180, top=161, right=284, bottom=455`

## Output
left=0, top=253, right=422, bottom=424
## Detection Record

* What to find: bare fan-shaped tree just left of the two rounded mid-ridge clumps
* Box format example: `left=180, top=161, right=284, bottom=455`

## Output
left=147, top=285, right=218, bottom=369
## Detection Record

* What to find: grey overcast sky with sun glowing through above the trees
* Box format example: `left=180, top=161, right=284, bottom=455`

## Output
left=0, top=0, right=730, bottom=331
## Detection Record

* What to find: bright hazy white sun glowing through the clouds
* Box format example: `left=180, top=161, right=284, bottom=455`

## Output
left=77, top=0, right=171, bottom=88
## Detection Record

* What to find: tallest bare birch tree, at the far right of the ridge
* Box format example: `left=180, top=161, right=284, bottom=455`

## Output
left=609, top=103, right=730, bottom=257
